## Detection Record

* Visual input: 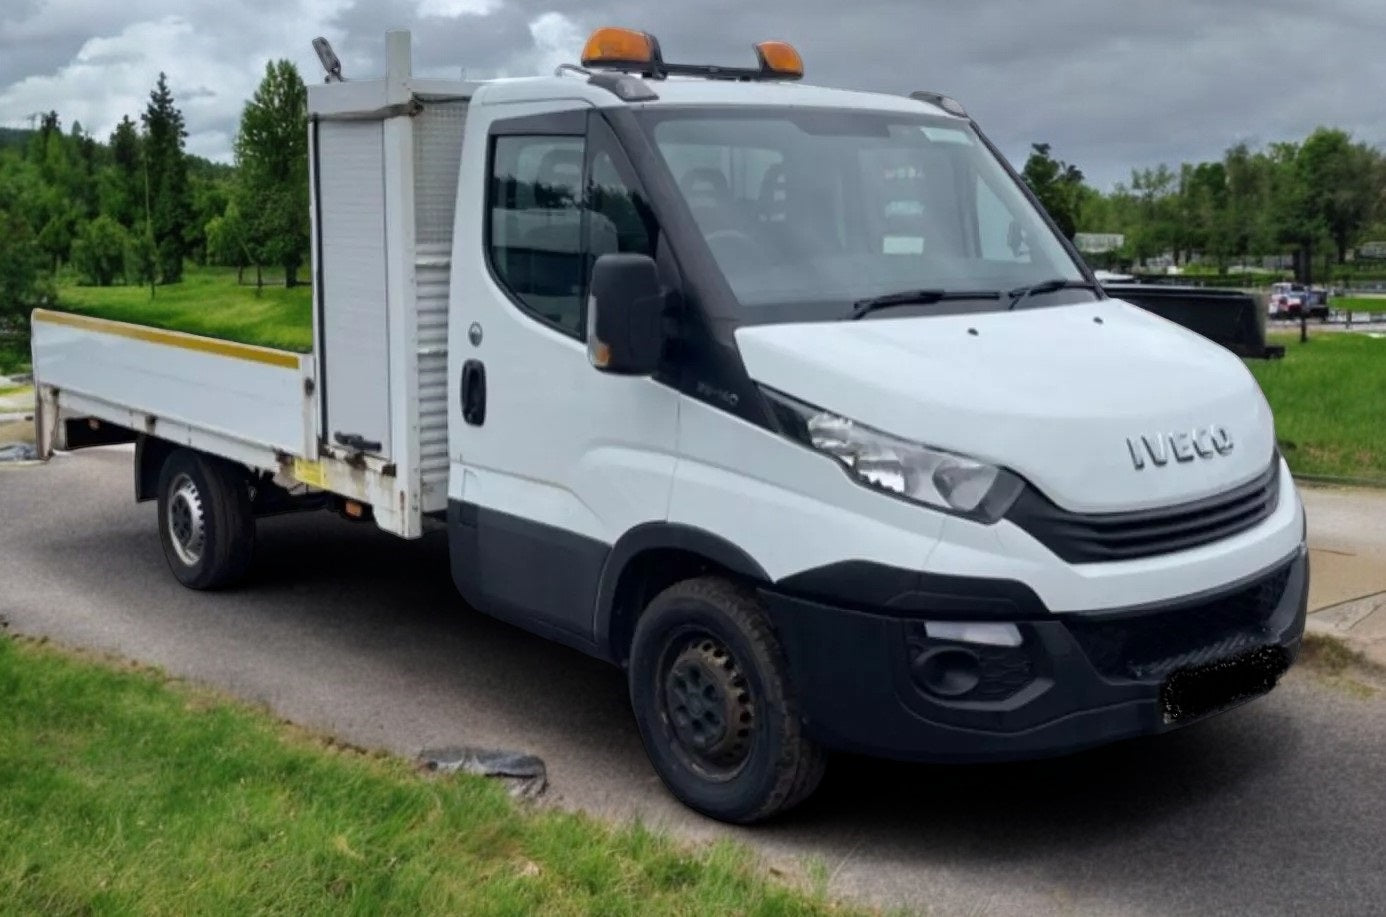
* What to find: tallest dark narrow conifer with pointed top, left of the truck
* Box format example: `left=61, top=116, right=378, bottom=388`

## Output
left=140, top=73, right=191, bottom=284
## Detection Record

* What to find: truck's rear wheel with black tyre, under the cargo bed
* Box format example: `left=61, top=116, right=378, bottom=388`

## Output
left=158, top=449, right=255, bottom=590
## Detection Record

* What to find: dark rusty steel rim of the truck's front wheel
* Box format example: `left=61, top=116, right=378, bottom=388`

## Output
left=656, top=629, right=757, bottom=783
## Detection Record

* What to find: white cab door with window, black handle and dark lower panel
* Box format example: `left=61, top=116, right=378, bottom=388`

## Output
left=449, top=98, right=678, bottom=644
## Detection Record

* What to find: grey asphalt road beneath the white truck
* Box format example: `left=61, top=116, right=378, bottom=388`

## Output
left=0, top=449, right=1386, bottom=914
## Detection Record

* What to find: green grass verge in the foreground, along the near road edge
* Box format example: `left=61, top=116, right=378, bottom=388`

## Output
left=0, top=636, right=843, bottom=914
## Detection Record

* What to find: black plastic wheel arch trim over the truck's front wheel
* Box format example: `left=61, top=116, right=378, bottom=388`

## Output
left=593, top=522, right=771, bottom=666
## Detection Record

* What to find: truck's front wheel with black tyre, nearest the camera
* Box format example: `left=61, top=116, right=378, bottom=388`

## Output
left=629, top=578, right=825, bottom=824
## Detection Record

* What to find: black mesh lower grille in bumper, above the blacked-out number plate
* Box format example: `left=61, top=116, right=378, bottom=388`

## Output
left=1064, top=564, right=1292, bottom=680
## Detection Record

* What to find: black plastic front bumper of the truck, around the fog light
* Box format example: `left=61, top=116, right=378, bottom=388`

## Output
left=765, top=549, right=1308, bottom=762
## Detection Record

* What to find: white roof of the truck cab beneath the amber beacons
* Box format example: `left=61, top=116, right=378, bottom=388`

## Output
left=473, top=73, right=955, bottom=118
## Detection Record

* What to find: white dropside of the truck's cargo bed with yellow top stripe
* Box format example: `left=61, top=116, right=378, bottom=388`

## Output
left=32, top=309, right=421, bottom=536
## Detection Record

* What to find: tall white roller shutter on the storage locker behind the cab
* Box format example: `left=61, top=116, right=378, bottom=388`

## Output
left=317, top=122, right=391, bottom=457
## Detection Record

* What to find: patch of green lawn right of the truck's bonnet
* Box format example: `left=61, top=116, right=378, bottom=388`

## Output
left=1250, top=332, right=1386, bottom=482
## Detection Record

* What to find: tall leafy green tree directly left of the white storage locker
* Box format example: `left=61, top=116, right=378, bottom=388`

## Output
left=236, top=61, right=308, bottom=287
